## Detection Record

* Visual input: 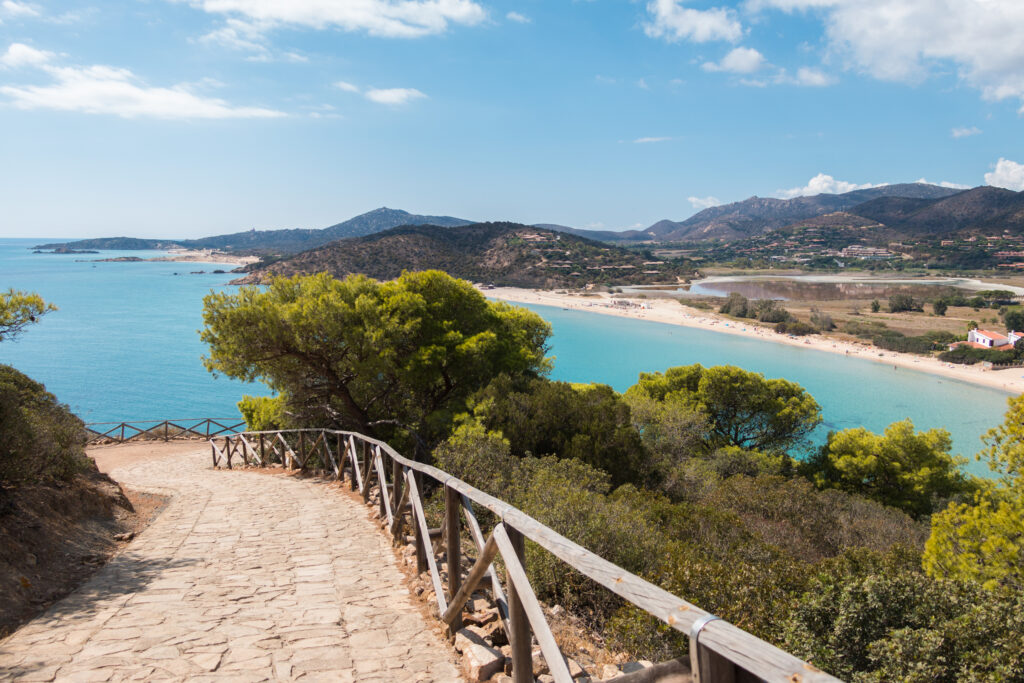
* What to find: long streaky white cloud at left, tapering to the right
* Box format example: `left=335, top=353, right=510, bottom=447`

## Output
left=0, top=51, right=285, bottom=119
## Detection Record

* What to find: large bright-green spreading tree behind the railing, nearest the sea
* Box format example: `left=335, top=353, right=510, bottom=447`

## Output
left=202, top=270, right=551, bottom=453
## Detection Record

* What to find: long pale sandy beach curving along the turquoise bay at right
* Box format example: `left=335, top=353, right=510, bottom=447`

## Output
left=483, top=287, right=1024, bottom=394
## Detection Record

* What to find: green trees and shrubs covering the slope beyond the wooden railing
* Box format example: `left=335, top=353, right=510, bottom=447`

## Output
left=205, top=272, right=1024, bottom=683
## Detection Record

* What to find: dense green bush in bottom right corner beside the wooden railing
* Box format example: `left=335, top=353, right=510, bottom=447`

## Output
left=784, top=551, right=1024, bottom=683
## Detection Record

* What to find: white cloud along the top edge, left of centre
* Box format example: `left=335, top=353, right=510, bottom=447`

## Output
left=178, top=0, right=486, bottom=38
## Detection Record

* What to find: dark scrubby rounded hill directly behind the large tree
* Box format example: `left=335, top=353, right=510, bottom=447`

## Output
left=238, top=223, right=692, bottom=288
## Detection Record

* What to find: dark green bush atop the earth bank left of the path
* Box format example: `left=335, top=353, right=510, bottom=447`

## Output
left=0, top=365, right=92, bottom=492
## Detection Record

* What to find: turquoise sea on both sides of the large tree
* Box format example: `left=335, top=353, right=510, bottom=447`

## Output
left=0, top=239, right=1009, bottom=473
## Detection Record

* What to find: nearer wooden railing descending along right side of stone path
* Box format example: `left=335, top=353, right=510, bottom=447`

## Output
left=210, top=429, right=838, bottom=683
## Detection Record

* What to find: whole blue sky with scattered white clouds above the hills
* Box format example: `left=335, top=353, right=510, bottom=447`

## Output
left=0, top=0, right=1024, bottom=238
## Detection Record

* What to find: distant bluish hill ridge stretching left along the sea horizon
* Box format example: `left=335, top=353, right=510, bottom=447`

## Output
left=34, top=207, right=472, bottom=255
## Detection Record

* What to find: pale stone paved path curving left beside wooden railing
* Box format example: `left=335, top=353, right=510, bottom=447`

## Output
left=0, top=446, right=461, bottom=682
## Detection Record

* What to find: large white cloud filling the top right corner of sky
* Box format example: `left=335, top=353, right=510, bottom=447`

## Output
left=748, top=0, right=1024, bottom=112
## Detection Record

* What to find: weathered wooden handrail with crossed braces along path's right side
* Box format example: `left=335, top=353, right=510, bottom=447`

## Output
left=210, top=429, right=838, bottom=683
